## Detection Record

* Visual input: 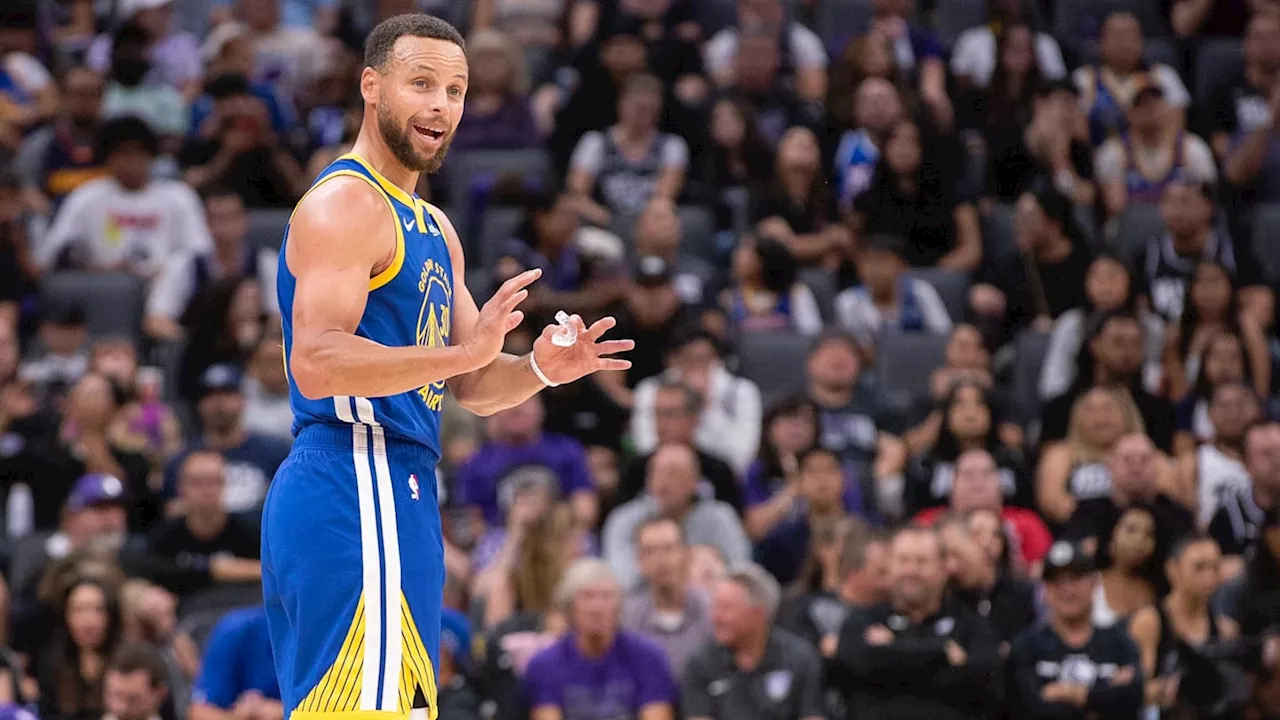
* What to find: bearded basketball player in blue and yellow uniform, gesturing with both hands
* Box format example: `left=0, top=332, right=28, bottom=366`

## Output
left=262, top=15, right=634, bottom=720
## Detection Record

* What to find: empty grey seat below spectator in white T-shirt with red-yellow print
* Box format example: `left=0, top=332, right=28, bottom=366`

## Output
left=41, top=270, right=147, bottom=340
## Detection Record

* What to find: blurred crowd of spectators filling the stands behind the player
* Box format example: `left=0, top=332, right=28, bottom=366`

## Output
left=0, top=0, right=1280, bottom=720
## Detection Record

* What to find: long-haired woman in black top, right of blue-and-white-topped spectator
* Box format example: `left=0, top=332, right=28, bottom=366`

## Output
left=852, top=117, right=982, bottom=272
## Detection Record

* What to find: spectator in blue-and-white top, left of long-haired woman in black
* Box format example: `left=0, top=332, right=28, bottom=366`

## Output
left=833, top=80, right=906, bottom=213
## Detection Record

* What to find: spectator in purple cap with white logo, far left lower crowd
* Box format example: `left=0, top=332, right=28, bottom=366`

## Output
left=9, top=474, right=128, bottom=598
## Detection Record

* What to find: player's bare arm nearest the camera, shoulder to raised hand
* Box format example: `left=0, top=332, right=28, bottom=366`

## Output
left=284, top=178, right=540, bottom=400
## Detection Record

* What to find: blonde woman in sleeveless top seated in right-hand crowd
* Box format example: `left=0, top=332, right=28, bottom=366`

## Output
left=1036, top=387, right=1146, bottom=524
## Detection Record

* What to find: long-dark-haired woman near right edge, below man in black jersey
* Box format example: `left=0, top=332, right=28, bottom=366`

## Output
left=1164, top=260, right=1271, bottom=404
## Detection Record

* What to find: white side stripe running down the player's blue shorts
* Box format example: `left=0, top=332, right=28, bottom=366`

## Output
left=350, top=422, right=383, bottom=710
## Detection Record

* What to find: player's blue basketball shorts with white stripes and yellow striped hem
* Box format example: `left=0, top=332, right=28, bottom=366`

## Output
left=262, top=424, right=444, bottom=720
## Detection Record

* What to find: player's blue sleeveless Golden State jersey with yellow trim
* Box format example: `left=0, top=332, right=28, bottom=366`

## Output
left=276, top=154, right=453, bottom=459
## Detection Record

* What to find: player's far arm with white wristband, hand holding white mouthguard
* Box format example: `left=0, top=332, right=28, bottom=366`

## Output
left=431, top=204, right=635, bottom=415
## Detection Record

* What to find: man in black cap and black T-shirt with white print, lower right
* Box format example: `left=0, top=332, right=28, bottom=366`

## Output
left=1009, top=541, right=1143, bottom=720
